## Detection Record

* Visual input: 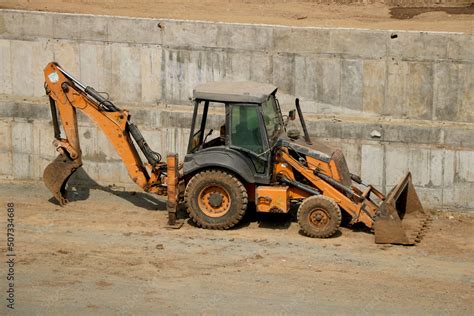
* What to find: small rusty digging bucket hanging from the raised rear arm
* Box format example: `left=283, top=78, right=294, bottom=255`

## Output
left=43, top=154, right=82, bottom=206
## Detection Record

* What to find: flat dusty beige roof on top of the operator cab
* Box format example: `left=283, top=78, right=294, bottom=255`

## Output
left=193, top=81, right=278, bottom=103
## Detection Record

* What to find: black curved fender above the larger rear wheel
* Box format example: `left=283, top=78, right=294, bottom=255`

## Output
left=183, top=147, right=256, bottom=183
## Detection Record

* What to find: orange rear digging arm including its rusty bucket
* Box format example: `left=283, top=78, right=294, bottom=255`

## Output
left=43, top=63, right=166, bottom=205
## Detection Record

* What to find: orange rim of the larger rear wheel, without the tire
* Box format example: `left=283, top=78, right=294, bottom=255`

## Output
left=198, top=185, right=230, bottom=217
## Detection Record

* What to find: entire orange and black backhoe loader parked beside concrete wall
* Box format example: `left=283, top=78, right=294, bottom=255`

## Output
left=43, top=62, right=428, bottom=245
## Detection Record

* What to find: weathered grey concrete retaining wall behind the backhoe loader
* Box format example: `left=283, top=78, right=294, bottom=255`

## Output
left=0, top=10, right=474, bottom=209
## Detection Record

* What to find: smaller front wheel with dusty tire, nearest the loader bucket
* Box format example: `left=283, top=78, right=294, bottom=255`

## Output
left=298, top=195, right=341, bottom=238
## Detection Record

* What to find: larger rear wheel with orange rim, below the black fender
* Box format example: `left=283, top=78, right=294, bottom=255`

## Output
left=184, top=170, right=248, bottom=229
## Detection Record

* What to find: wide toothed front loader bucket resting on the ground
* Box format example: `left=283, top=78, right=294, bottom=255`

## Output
left=374, top=173, right=430, bottom=245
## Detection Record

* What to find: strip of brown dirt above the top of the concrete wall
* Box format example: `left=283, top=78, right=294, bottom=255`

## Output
left=0, top=0, right=474, bottom=33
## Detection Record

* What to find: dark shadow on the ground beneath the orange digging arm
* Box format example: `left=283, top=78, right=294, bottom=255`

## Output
left=60, top=167, right=166, bottom=211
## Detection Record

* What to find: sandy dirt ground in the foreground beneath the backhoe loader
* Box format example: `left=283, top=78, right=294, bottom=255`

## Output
left=0, top=182, right=474, bottom=315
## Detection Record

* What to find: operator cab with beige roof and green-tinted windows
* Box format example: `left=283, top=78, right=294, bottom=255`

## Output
left=184, top=81, right=284, bottom=183
